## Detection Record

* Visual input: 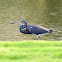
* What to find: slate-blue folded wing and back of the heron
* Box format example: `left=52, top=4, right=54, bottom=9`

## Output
left=27, top=25, right=49, bottom=35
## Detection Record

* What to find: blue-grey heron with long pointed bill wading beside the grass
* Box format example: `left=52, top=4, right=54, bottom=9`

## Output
left=11, top=19, right=52, bottom=39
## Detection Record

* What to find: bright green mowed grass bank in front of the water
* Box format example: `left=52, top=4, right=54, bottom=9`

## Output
left=0, top=41, right=62, bottom=62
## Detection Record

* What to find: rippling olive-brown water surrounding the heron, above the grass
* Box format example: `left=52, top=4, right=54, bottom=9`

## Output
left=0, top=0, right=62, bottom=41
